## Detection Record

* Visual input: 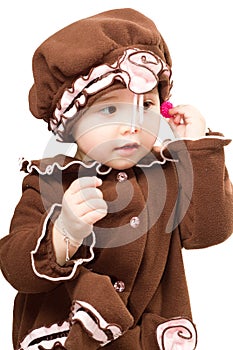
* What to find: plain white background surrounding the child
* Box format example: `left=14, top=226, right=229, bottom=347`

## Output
left=0, top=0, right=233, bottom=350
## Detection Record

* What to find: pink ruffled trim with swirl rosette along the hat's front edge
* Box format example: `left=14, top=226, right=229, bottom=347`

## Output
left=50, top=49, right=170, bottom=140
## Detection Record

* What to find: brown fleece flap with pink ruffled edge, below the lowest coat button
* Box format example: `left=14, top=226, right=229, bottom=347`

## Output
left=67, top=267, right=134, bottom=346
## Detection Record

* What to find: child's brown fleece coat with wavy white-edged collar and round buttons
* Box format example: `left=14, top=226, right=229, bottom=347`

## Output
left=0, top=135, right=233, bottom=350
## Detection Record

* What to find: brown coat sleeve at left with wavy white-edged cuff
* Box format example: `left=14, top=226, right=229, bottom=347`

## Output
left=0, top=174, right=92, bottom=293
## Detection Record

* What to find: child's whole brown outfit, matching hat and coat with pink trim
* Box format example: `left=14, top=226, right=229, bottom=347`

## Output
left=0, top=9, right=233, bottom=350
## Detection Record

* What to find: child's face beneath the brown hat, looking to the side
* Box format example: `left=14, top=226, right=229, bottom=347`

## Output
left=73, top=89, right=160, bottom=170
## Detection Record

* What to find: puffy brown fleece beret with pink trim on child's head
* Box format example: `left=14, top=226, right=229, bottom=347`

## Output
left=29, top=9, right=171, bottom=139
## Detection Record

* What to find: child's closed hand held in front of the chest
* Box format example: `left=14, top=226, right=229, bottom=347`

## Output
left=57, top=176, right=107, bottom=242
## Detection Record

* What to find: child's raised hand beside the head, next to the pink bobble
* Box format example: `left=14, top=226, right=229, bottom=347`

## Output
left=168, top=105, right=206, bottom=139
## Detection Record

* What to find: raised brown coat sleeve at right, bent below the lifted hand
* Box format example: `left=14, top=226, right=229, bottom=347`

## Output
left=168, top=135, right=233, bottom=249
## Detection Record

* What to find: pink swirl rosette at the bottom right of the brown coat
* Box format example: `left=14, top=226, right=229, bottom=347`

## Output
left=157, top=318, right=197, bottom=350
